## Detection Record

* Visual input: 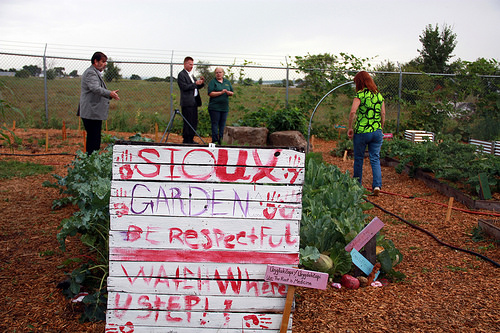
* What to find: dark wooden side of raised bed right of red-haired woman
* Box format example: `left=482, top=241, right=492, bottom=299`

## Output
left=380, top=157, right=500, bottom=212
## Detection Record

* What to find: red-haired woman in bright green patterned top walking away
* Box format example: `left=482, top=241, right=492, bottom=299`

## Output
left=347, top=71, right=385, bottom=195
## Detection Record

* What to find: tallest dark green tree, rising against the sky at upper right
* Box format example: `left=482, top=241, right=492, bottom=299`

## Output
left=418, top=24, right=457, bottom=73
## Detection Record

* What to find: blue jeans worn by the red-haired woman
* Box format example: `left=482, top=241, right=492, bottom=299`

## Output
left=353, top=130, right=384, bottom=188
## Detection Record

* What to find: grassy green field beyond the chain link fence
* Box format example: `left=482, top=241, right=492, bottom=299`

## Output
left=0, top=77, right=404, bottom=133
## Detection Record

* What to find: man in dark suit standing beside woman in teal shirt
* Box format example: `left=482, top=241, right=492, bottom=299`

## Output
left=177, top=57, right=205, bottom=143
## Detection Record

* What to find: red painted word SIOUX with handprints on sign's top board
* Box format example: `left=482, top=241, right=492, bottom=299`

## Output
left=116, top=148, right=300, bottom=184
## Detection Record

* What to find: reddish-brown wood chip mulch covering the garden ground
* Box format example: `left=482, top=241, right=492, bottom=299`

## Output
left=0, top=129, right=500, bottom=333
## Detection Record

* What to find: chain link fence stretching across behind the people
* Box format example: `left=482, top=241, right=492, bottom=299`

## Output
left=0, top=53, right=500, bottom=136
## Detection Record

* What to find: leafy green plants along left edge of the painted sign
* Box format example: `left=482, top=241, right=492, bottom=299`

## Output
left=44, top=149, right=112, bottom=320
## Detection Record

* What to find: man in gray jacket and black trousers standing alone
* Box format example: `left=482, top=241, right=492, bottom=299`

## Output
left=78, top=52, right=120, bottom=155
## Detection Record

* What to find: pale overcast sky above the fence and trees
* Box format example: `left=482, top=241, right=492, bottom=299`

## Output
left=0, top=0, right=500, bottom=65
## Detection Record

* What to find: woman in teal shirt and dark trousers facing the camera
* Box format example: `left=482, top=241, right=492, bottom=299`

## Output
left=208, top=67, right=234, bottom=145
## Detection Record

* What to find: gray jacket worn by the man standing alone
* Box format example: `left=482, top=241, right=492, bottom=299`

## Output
left=77, top=66, right=111, bottom=120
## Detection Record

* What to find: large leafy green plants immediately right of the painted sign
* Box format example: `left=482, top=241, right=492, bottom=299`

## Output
left=300, top=156, right=402, bottom=276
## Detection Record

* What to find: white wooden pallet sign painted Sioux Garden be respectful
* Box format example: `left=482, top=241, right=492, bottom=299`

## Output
left=106, top=142, right=305, bottom=333
